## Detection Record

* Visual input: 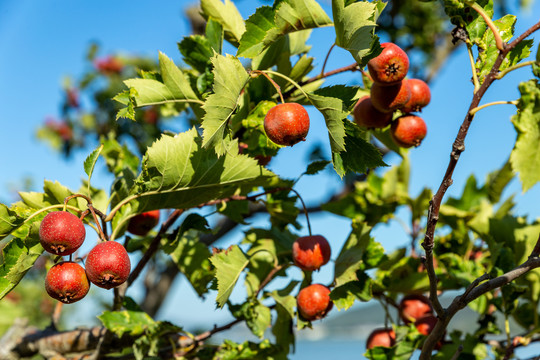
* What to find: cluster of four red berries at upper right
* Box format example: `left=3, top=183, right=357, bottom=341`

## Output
left=353, top=43, right=431, bottom=148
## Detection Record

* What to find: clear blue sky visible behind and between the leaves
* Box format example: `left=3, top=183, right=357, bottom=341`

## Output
left=0, top=0, right=540, bottom=332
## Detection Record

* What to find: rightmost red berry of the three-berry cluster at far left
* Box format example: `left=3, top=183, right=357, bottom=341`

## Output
left=86, top=241, right=131, bottom=289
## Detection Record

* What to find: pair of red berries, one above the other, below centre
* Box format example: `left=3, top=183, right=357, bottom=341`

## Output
left=293, top=235, right=333, bottom=321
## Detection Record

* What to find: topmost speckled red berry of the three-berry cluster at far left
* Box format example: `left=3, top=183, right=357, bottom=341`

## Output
left=39, top=211, right=86, bottom=256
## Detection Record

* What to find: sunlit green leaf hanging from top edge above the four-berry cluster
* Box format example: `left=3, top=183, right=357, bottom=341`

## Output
left=332, top=0, right=385, bottom=66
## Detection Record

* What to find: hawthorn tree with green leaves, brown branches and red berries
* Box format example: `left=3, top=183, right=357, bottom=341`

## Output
left=0, top=0, right=540, bottom=359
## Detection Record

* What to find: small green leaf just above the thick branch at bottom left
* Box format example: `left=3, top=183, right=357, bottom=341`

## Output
left=98, top=310, right=155, bottom=337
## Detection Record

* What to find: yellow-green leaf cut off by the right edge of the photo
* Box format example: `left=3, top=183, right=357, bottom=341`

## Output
left=510, top=80, right=540, bottom=191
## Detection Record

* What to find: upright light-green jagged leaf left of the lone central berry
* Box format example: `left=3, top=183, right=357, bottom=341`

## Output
left=202, top=54, right=249, bottom=155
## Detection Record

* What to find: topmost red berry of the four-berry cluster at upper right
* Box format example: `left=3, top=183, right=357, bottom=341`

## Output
left=367, top=43, right=409, bottom=85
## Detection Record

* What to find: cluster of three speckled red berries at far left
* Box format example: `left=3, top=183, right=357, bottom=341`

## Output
left=39, top=211, right=143, bottom=304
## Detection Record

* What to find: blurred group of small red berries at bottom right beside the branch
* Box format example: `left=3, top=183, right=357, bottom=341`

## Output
left=366, top=294, right=440, bottom=349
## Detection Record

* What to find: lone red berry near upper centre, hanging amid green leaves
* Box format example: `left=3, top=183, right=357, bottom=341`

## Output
left=264, top=103, right=309, bottom=146
